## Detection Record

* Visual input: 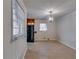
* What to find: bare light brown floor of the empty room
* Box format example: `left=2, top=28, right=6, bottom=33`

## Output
left=25, top=41, right=76, bottom=59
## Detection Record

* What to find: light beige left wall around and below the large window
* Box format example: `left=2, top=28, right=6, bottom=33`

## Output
left=3, top=0, right=27, bottom=59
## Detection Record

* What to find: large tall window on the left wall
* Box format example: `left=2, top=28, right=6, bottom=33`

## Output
left=12, top=0, right=25, bottom=40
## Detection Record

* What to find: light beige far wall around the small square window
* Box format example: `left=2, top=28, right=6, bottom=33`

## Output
left=35, top=19, right=56, bottom=40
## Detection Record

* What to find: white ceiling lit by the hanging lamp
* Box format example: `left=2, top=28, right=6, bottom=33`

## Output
left=24, top=0, right=76, bottom=19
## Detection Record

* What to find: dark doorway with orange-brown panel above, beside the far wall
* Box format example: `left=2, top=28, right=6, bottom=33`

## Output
left=27, top=19, right=34, bottom=42
